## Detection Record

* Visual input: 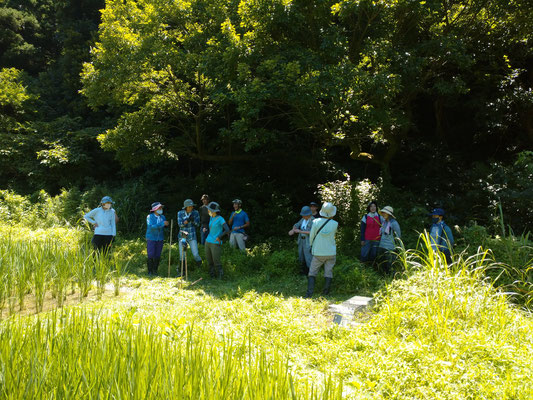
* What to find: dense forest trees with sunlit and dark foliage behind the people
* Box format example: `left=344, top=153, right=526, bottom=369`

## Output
left=0, top=0, right=533, bottom=231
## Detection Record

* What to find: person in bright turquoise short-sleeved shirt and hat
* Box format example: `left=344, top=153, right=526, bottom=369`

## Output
left=205, top=201, right=229, bottom=279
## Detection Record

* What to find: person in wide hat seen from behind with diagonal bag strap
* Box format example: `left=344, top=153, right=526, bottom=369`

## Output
left=305, top=202, right=339, bottom=298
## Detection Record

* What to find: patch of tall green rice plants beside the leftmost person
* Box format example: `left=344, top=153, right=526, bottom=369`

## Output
left=0, top=226, right=118, bottom=314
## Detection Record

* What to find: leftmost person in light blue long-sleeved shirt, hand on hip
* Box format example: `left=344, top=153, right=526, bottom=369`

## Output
left=84, top=196, right=118, bottom=253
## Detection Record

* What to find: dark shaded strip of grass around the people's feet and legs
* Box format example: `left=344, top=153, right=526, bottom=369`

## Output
left=116, top=239, right=391, bottom=302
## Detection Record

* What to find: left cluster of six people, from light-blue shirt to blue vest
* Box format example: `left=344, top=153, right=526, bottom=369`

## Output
left=85, top=194, right=250, bottom=278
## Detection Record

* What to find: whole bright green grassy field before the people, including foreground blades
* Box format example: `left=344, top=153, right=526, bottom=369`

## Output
left=0, top=230, right=533, bottom=399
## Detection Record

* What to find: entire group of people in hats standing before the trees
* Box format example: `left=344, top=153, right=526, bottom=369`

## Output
left=85, top=194, right=454, bottom=297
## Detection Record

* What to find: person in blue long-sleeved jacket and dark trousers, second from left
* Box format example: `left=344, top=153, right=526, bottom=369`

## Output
left=146, top=201, right=168, bottom=276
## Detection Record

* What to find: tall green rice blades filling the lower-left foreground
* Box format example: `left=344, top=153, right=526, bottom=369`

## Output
left=0, top=309, right=342, bottom=400
